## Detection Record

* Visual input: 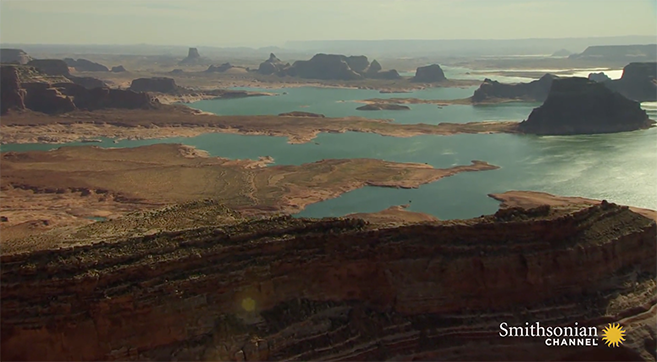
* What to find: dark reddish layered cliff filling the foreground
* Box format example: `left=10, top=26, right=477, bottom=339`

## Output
left=0, top=202, right=657, bottom=362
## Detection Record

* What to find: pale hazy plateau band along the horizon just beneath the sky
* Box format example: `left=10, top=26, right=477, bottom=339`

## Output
left=5, top=36, right=657, bottom=59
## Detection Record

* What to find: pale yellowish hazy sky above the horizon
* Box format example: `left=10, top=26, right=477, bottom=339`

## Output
left=0, top=0, right=657, bottom=46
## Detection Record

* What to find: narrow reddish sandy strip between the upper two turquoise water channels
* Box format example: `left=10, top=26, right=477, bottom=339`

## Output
left=0, top=109, right=518, bottom=144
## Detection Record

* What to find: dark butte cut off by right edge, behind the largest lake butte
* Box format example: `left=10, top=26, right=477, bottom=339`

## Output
left=607, top=63, right=657, bottom=102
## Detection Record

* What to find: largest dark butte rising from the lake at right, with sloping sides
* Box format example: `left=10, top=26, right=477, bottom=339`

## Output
left=519, top=78, right=654, bottom=135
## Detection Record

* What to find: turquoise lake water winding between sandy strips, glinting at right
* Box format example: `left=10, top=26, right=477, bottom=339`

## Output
left=0, top=88, right=657, bottom=219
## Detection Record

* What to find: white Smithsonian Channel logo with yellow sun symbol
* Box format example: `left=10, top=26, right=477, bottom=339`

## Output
left=499, top=322, right=626, bottom=347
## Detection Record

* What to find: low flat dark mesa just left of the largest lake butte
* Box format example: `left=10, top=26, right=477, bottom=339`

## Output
left=472, top=74, right=559, bottom=103
